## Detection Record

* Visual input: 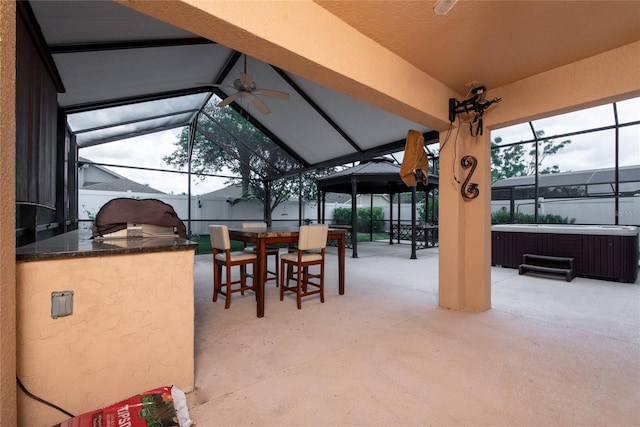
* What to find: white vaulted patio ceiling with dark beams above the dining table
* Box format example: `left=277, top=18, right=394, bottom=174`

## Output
left=23, top=1, right=437, bottom=177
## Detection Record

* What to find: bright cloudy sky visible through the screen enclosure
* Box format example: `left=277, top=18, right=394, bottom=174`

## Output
left=79, top=98, right=640, bottom=195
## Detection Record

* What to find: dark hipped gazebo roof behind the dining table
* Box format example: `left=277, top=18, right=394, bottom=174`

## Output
left=316, top=158, right=438, bottom=194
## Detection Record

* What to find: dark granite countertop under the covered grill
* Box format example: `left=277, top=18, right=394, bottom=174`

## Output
left=16, top=230, right=197, bottom=261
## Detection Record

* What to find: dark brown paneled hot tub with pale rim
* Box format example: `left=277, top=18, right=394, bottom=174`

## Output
left=491, top=224, right=638, bottom=283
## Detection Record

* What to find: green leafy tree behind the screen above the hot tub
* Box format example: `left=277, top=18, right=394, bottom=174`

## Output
left=491, top=130, right=571, bottom=183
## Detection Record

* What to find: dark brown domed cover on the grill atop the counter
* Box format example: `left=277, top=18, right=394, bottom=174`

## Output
left=93, top=198, right=187, bottom=239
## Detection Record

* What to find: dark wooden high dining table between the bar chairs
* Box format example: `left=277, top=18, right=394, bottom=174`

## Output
left=229, top=227, right=347, bottom=317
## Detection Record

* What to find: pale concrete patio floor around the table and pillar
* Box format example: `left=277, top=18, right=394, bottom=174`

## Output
left=189, top=242, right=640, bottom=427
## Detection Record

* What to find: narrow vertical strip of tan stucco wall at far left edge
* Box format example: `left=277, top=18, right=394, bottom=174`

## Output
left=0, top=1, right=16, bottom=426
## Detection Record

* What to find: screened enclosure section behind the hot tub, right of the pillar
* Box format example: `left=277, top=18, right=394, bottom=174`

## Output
left=491, top=98, right=640, bottom=226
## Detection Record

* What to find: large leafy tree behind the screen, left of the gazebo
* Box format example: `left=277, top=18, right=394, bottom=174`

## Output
left=163, top=100, right=335, bottom=212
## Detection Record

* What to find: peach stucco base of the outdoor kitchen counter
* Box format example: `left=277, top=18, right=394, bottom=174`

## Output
left=16, top=249, right=194, bottom=427
